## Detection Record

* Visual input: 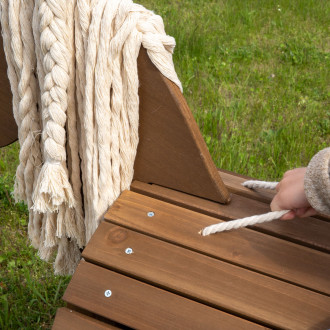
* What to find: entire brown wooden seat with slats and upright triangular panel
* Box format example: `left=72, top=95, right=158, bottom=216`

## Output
left=0, top=43, right=330, bottom=330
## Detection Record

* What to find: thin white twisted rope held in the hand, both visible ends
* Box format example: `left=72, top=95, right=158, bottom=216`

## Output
left=199, top=180, right=290, bottom=236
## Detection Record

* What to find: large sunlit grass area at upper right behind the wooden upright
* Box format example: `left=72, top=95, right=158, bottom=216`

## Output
left=143, top=0, right=330, bottom=179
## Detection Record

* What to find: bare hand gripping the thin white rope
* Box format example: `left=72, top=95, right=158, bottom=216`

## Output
left=270, top=167, right=316, bottom=220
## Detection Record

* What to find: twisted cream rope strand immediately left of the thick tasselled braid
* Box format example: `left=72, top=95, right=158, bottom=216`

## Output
left=18, top=0, right=42, bottom=246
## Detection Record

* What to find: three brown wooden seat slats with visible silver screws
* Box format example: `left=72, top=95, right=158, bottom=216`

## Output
left=64, top=187, right=330, bottom=329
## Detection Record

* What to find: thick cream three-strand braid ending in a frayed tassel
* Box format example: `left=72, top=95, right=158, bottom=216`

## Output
left=33, top=0, right=75, bottom=213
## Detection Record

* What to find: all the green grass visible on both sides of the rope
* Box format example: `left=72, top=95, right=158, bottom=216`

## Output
left=0, top=0, right=330, bottom=329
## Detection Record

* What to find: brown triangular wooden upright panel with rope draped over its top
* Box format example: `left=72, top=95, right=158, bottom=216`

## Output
left=134, top=48, right=229, bottom=203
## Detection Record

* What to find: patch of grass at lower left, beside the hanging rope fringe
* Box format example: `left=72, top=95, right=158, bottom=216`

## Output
left=0, top=143, right=70, bottom=329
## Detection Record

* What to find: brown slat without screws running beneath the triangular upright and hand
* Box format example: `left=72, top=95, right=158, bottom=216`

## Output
left=131, top=181, right=330, bottom=252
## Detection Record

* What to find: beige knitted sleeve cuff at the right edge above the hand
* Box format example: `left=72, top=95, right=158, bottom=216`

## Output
left=304, top=148, right=330, bottom=215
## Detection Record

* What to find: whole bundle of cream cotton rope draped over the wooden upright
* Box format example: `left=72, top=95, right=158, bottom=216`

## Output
left=0, top=0, right=182, bottom=274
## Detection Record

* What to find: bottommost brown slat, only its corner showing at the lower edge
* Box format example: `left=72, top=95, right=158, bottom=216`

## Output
left=52, top=307, right=120, bottom=330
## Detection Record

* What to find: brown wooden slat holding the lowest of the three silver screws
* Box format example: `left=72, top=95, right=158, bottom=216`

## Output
left=63, top=261, right=260, bottom=329
